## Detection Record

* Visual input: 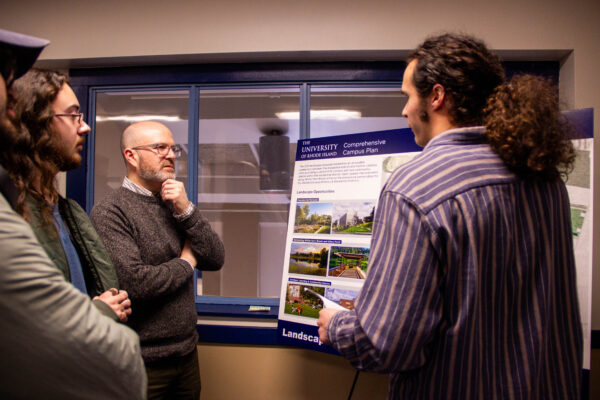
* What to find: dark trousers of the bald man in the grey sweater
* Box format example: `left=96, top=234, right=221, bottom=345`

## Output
left=146, top=348, right=200, bottom=400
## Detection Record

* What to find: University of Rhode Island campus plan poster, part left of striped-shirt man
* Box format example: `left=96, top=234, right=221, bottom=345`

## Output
left=277, top=129, right=421, bottom=352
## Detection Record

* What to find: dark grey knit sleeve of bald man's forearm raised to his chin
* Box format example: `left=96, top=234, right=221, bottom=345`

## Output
left=179, top=207, right=225, bottom=271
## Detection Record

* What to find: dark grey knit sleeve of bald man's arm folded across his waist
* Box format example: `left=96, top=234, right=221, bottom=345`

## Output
left=90, top=198, right=194, bottom=301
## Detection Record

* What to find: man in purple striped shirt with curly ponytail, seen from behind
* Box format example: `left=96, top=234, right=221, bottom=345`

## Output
left=317, top=34, right=583, bottom=399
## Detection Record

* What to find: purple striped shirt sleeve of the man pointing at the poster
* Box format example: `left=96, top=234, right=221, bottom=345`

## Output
left=327, top=193, right=442, bottom=373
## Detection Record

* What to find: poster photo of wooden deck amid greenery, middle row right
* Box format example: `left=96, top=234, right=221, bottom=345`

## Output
left=327, top=246, right=371, bottom=279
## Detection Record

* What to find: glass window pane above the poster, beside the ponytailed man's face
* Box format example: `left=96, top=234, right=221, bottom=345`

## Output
left=310, top=86, right=408, bottom=138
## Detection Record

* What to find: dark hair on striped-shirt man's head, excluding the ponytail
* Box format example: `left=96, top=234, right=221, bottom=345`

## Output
left=408, top=33, right=505, bottom=126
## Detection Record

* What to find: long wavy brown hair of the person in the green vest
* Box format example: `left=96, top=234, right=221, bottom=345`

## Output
left=4, top=69, right=69, bottom=221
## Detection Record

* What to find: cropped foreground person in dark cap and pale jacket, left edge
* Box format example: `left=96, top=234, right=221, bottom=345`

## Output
left=0, top=29, right=146, bottom=399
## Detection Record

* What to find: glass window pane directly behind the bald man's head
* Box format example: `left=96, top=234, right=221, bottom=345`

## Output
left=94, top=90, right=189, bottom=203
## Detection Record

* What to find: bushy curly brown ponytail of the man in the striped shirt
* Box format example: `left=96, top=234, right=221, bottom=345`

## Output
left=484, top=75, right=576, bottom=179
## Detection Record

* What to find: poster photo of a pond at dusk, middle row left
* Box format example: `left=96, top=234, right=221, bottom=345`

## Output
left=288, top=243, right=329, bottom=276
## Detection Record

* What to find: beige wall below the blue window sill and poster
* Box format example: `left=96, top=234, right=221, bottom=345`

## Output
left=198, top=344, right=388, bottom=400
